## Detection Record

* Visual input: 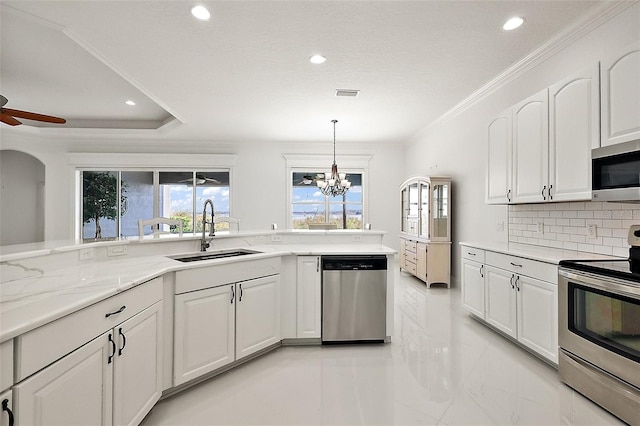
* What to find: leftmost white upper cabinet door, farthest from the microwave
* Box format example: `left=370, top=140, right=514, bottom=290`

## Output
left=486, top=108, right=512, bottom=204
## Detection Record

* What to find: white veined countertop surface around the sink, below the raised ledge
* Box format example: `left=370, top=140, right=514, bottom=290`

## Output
left=0, top=243, right=396, bottom=342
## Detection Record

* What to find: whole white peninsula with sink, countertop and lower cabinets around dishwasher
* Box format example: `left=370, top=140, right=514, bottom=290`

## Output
left=0, top=231, right=395, bottom=424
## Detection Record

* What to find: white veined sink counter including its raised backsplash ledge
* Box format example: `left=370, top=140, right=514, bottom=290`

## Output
left=0, top=231, right=396, bottom=342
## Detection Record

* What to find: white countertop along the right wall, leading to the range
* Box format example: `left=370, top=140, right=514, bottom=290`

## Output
left=460, top=242, right=620, bottom=265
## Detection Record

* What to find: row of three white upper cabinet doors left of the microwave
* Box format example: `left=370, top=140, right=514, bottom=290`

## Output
left=486, top=60, right=600, bottom=204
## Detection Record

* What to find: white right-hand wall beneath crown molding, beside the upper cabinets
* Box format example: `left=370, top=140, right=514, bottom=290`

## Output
left=405, top=3, right=640, bottom=281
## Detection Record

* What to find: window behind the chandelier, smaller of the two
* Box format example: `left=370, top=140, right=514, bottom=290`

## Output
left=291, top=170, right=363, bottom=229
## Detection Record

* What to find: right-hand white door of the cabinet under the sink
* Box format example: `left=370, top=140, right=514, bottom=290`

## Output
left=236, top=275, right=280, bottom=359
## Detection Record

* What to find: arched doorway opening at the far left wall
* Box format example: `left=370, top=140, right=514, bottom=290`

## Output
left=0, top=150, right=45, bottom=246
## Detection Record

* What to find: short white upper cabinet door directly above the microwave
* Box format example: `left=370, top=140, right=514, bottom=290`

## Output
left=600, top=41, right=640, bottom=146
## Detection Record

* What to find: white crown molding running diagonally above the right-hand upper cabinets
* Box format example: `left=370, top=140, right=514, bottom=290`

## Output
left=409, top=0, right=639, bottom=143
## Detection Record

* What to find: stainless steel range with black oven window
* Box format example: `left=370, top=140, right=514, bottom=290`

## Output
left=558, top=227, right=640, bottom=425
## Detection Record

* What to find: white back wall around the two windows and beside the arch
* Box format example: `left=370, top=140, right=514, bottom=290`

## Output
left=2, top=128, right=404, bottom=248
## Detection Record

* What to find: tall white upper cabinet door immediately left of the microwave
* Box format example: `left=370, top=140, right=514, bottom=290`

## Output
left=547, top=64, right=600, bottom=201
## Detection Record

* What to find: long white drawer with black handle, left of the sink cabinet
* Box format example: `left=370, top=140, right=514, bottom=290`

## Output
left=15, top=277, right=163, bottom=382
